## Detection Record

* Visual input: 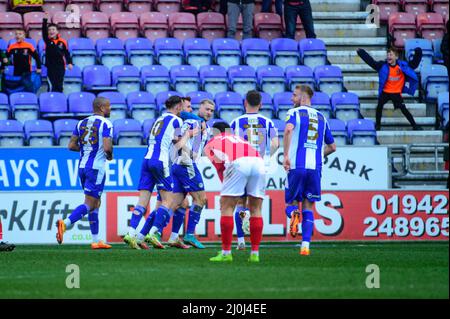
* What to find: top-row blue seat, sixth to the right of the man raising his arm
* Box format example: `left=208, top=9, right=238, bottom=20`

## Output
left=211, top=38, right=241, bottom=69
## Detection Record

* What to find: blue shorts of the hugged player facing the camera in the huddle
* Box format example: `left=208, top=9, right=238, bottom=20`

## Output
left=172, top=164, right=205, bottom=194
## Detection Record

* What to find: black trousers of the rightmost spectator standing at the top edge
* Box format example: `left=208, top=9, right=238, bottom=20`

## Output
left=284, top=0, right=316, bottom=39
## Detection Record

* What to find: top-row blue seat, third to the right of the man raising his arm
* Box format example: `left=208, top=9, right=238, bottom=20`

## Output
left=125, top=38, right=153, bottom=69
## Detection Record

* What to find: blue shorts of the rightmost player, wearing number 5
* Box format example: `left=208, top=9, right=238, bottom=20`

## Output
left=284, top=168, right=322, bottom=203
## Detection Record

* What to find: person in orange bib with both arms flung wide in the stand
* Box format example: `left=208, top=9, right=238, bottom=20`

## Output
left=356, top=48, right=422, bottom=131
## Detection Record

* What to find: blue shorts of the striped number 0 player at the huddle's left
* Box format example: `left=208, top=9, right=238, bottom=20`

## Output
left=138, top=159, right=173, bottom=192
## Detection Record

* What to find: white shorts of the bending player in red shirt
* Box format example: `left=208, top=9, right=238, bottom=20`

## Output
left=220, top=157, right=266, bottom=198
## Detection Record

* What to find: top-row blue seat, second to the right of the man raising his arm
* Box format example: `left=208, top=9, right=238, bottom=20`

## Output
left=96, top=38, right=125, bottom=70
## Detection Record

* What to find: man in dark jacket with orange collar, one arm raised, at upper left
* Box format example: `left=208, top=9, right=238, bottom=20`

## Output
left=42, top=18, right=73, bottom=92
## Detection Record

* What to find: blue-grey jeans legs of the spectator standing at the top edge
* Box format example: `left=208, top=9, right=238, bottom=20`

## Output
left=227, top=0, right=255, bottom=39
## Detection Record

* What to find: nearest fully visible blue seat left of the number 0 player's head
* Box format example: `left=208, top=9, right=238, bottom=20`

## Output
left=127, top=92, right=158, bottom=124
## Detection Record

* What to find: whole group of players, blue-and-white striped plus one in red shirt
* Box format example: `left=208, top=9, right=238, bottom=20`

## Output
left=56, top=85, right=336, bottom=262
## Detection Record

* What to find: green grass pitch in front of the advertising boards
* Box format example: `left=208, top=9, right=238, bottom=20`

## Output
left=0, top=242, right=449, bottom=299
